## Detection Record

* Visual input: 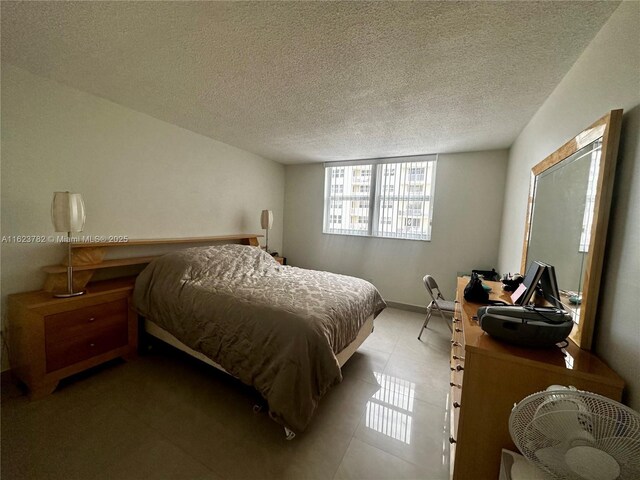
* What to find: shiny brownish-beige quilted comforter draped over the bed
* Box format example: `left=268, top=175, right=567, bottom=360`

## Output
left=134, top=245, right=386, bottom=432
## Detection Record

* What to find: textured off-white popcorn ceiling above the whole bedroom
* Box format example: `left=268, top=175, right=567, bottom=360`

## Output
left=2, top=1, right=618, bottom=163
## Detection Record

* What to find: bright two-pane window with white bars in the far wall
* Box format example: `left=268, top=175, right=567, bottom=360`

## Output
left=323, top=155, right=437, bottom=240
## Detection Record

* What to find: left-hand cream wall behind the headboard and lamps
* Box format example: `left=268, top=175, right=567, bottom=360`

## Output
left=1, top=64, right=285, bottom=368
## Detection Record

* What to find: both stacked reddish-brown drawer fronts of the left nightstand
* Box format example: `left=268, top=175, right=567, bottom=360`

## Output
left=45, top=298, right=129, bottom=372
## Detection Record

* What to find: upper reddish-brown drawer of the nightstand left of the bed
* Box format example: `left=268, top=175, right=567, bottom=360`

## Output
left=44, top=298, right=127, bottom=344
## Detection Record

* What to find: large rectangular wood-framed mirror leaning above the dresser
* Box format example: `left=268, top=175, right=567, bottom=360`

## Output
left=521, top=110, right=622, bottom=350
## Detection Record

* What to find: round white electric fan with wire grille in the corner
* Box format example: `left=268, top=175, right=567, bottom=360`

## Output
left=509, top=385, right=640, bottom=480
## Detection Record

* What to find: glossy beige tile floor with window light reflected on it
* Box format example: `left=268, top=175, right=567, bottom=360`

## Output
left=1, top=308, right=450, bottom=480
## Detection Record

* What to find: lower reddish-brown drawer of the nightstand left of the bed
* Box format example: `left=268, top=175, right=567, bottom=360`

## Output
left=45, top=317, right=129, bottom=372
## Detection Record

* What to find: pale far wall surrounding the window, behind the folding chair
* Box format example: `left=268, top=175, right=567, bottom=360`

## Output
left=283, top=150, right=507, bottom=306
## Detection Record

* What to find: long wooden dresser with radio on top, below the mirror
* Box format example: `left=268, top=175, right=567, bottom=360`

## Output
left=449, top=277, right=624, bottom=480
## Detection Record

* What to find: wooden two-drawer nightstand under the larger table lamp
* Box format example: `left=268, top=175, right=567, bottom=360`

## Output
left=7, top=278, right=138, bottom=399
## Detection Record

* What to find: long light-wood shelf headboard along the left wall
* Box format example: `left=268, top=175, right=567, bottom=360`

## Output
left=42, top=233, right=262, bottom=292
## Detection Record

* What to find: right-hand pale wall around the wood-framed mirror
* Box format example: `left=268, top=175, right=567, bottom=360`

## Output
left=499, top=2, right=640, bottom=410
